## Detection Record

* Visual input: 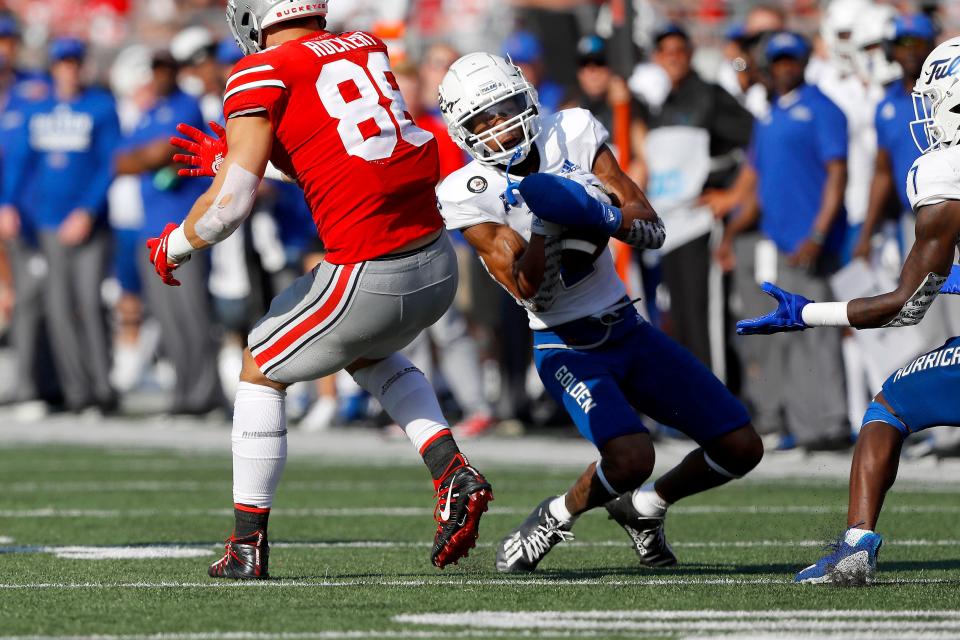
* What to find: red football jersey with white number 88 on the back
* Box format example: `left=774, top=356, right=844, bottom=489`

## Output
left=223, top=31, right=443, bottom=264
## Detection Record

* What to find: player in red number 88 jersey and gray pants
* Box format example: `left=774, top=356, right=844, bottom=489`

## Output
left=148, top=0, right=493, bottom=579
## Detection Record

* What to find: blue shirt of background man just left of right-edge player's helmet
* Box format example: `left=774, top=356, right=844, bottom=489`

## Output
left=874, top=80, right=920, bottom=211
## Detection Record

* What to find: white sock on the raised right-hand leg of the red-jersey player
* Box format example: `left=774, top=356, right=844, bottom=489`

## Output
left=353, top=353, right=450, bottom=454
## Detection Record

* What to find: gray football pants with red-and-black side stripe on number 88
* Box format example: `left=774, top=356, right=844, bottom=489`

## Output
left=249, top=233, right=457, bottom=384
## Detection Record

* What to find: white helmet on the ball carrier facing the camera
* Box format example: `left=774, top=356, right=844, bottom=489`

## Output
left=440, top=53, right=541, bottom=165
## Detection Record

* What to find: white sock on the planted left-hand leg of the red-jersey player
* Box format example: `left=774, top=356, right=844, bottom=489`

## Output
left=231, top=382, right=287, bottom=509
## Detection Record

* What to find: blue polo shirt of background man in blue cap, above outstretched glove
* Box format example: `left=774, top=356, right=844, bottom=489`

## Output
left=751, top=84, right=847, bottom=253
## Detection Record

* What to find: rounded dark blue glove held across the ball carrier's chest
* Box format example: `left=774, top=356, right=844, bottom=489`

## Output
left=520, top=173, right=623, bottom=236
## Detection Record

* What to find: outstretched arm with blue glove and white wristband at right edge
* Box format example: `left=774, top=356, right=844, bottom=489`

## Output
left=737, top=201, right=960, bottom=335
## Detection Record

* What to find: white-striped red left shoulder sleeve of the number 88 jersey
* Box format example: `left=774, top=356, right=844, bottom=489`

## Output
left=223, top=55, right=288, bottom=126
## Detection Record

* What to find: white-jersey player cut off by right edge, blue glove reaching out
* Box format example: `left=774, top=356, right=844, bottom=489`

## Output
left=737, top=37, right=960, bottom=585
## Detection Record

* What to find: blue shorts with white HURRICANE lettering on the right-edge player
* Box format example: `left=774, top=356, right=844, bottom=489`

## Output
left=863, top=336, right=960, bottom=435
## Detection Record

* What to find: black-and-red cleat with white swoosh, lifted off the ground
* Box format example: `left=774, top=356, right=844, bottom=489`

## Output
left=430, top=453, right=493, bottom=569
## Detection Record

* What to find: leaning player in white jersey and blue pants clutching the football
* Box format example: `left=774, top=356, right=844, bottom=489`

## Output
left=437, top=53, right=763, bottom=572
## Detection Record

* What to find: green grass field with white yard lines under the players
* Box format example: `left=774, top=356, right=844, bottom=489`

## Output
left=0, top=447, right=960, bottom=640
